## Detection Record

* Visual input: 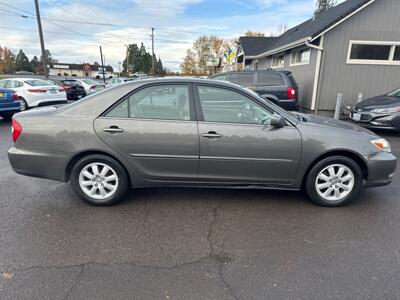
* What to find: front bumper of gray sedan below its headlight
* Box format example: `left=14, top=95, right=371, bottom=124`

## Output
left=365, top=151, right=397, bottom=187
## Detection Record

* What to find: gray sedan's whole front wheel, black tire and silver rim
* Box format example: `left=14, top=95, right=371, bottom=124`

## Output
left=306, top=156, right=364, bottom=207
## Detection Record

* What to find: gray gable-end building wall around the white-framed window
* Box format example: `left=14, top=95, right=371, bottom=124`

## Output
left=317, top=0, right=400, bottom=115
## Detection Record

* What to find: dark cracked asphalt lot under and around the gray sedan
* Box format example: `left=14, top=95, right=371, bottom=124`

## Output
left=0, top=120, right=400, bottom=300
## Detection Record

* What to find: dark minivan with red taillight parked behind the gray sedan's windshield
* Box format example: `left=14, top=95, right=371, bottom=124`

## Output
left=210, top=69, right=299, bottom=110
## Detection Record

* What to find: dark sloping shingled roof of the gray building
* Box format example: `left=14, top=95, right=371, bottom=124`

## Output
left=241, top=0, right=375, bottom=56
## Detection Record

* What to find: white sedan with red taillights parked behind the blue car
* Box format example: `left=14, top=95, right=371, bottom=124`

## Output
left=0, top=78, right=67, bottom=110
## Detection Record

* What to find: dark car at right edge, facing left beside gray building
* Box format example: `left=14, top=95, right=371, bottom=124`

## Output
left=350, top=89, right=400, bottom=131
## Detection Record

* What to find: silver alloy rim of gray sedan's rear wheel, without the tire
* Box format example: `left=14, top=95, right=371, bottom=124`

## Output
left=79, top=163, right=119, bottom=200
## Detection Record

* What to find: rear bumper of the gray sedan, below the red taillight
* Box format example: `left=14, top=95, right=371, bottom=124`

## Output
left=8, top=147, right=69, bottom=182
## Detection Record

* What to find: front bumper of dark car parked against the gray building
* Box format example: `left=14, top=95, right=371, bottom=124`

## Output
left=350, top=110, right=400, bottom=131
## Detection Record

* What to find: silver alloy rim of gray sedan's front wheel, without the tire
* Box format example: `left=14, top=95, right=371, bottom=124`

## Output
left=315, top=164, right=355, bottom=201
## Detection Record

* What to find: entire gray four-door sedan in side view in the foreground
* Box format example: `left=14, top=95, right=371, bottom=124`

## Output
left=8, top=78, right=396, bottom=206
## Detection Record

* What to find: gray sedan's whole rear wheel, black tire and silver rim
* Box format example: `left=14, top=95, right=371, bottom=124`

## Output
left=70, top=154, right=129, bottom=206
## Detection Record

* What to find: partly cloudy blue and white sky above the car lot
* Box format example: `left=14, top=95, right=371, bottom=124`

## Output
left=0, top=0, right=344, bottom=70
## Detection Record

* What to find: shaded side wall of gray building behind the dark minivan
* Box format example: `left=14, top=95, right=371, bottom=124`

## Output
left=245, top=49, right=318, bottom=110
